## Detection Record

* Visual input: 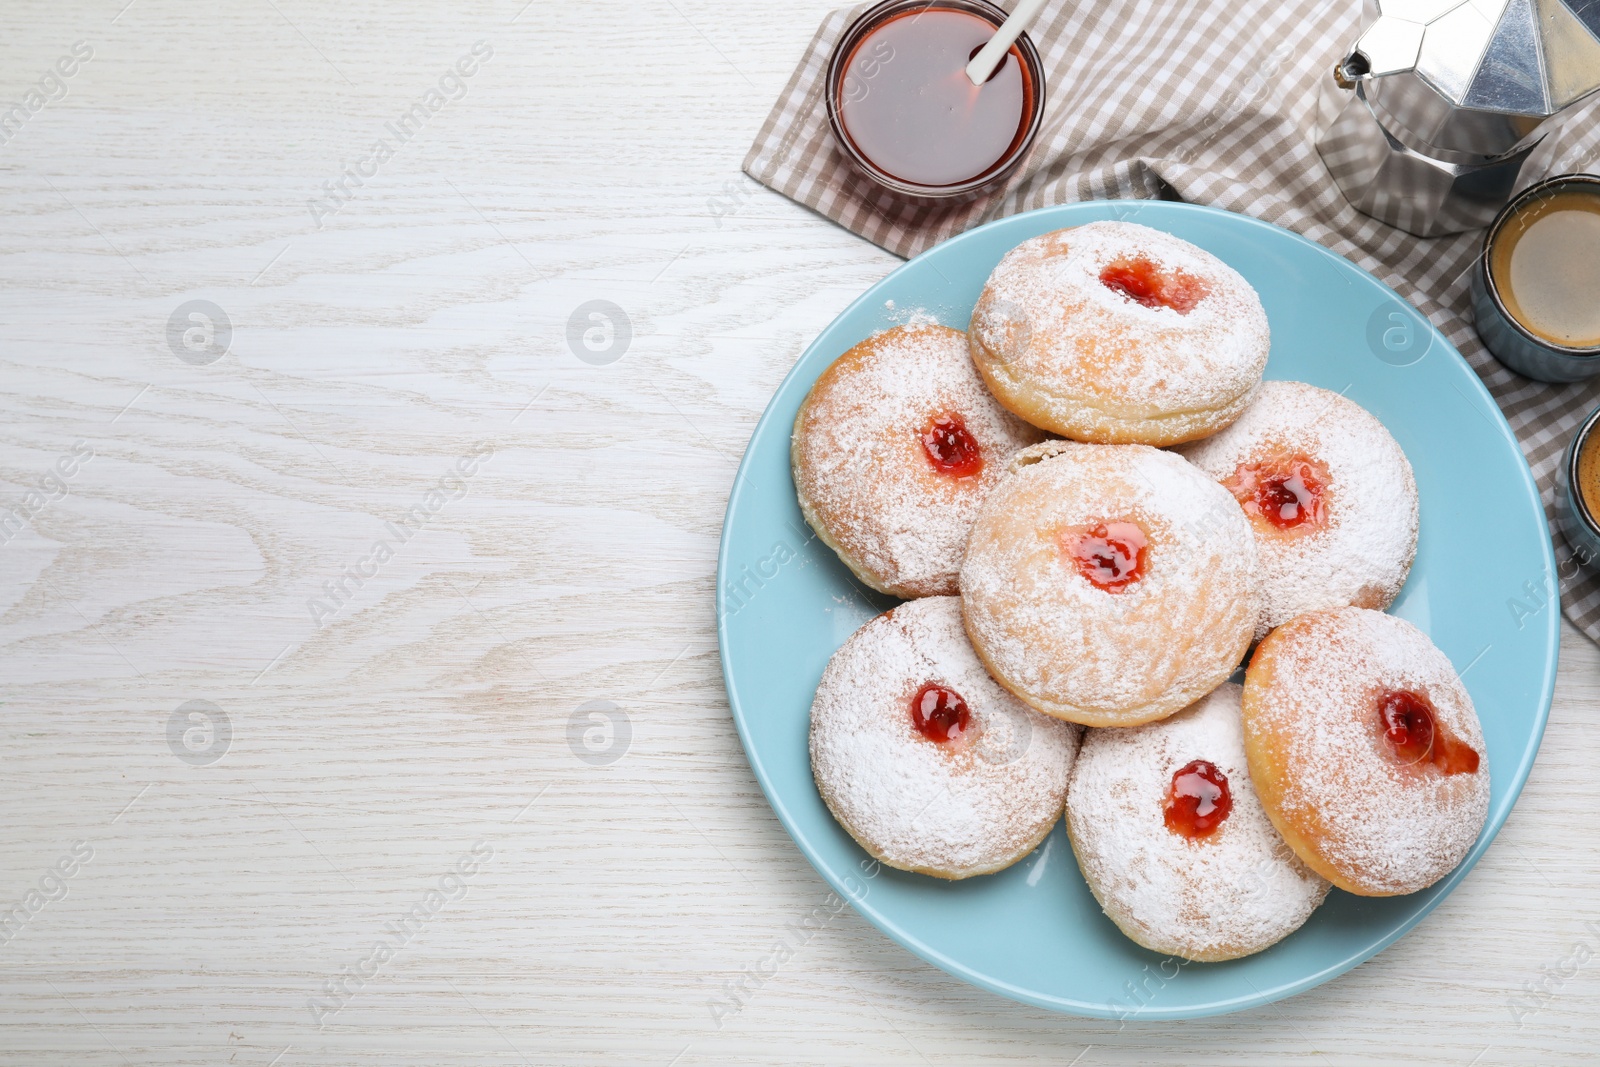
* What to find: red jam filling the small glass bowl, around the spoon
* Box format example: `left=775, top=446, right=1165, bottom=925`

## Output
left=835, top=3, right=1035, bottom=189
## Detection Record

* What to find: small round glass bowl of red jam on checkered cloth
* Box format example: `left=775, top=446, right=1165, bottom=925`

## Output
left=826, top=0, right=1045, bottom=200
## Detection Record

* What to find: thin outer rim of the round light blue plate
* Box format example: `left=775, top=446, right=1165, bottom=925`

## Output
left=712, top=200, right=1562, bottom=1022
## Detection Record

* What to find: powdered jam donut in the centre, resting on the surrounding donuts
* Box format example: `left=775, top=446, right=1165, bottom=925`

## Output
left=962, top=442, right=1258, bottom=726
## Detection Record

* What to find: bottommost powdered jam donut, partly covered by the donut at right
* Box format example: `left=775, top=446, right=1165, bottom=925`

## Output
left=1067, top=685, right=1328, bottom=961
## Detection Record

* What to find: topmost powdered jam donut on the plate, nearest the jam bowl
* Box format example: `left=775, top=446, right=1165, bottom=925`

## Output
left=968, top=222, right=1269, bottom=445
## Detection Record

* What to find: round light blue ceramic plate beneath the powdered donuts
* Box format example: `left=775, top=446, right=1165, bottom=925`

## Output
left=717, top=202, right=1558, bottom=1019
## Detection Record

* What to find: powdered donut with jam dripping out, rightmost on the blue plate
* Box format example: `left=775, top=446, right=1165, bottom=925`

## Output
left=1245, top=608, right=1490, bottom=896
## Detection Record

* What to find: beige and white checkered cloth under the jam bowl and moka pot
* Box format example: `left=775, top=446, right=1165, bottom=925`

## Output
left=744, top=0, right=1600, bottom=641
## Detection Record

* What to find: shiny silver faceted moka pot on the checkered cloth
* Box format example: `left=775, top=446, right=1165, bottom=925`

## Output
left=1317, top=0, right=1600, bottom=237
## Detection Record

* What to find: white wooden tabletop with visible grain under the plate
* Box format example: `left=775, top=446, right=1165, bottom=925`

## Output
left=0, top=0, right=1600, bottom=1067
